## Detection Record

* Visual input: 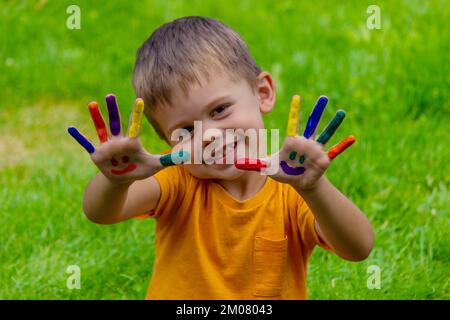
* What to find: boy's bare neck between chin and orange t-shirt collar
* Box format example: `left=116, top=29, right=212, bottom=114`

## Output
left=214, top=171, right=267, bottom=201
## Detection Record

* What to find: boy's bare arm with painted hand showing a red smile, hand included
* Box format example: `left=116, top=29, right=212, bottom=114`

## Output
left=68, top=95, right=189, bottom=224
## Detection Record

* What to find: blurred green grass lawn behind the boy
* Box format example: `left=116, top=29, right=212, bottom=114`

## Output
left=0, top=0, right=450, bottom=299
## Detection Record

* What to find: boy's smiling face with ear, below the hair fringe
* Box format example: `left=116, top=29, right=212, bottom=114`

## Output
left=153, top=72, right=275, bottom=180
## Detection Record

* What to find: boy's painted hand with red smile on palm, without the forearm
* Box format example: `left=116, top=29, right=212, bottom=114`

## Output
left=68, top=94, right=189, bottom=183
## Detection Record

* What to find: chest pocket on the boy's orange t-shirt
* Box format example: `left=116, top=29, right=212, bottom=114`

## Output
left=253, top=235, right=288, bottom=298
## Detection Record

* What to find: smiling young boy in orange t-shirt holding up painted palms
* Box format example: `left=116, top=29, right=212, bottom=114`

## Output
left=69, top=17, right=374, bottom=299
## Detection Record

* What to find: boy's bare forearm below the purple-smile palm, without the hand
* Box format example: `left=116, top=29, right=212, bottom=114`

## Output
left=294, top=176, right=374, bottom=261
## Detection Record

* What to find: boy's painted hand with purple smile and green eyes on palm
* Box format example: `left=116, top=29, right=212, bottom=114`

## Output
left=235, top=96, right=355, bottom=190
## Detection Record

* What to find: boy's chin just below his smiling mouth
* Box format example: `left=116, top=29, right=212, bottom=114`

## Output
left=184, top=164, right=245, bottom=181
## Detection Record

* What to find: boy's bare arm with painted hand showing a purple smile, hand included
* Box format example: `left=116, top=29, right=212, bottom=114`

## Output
left=236, top=96, right=374, bottom=261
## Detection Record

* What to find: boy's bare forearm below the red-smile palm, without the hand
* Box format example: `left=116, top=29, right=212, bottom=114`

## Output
left=83, top=173, right=161, bottom=224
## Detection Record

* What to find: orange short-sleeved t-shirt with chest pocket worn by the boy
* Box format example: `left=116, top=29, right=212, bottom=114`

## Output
left=142, top=166, right=329, bottom=299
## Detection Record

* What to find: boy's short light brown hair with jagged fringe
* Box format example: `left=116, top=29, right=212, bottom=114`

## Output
left=133, top=16, right=261, bottom=139
